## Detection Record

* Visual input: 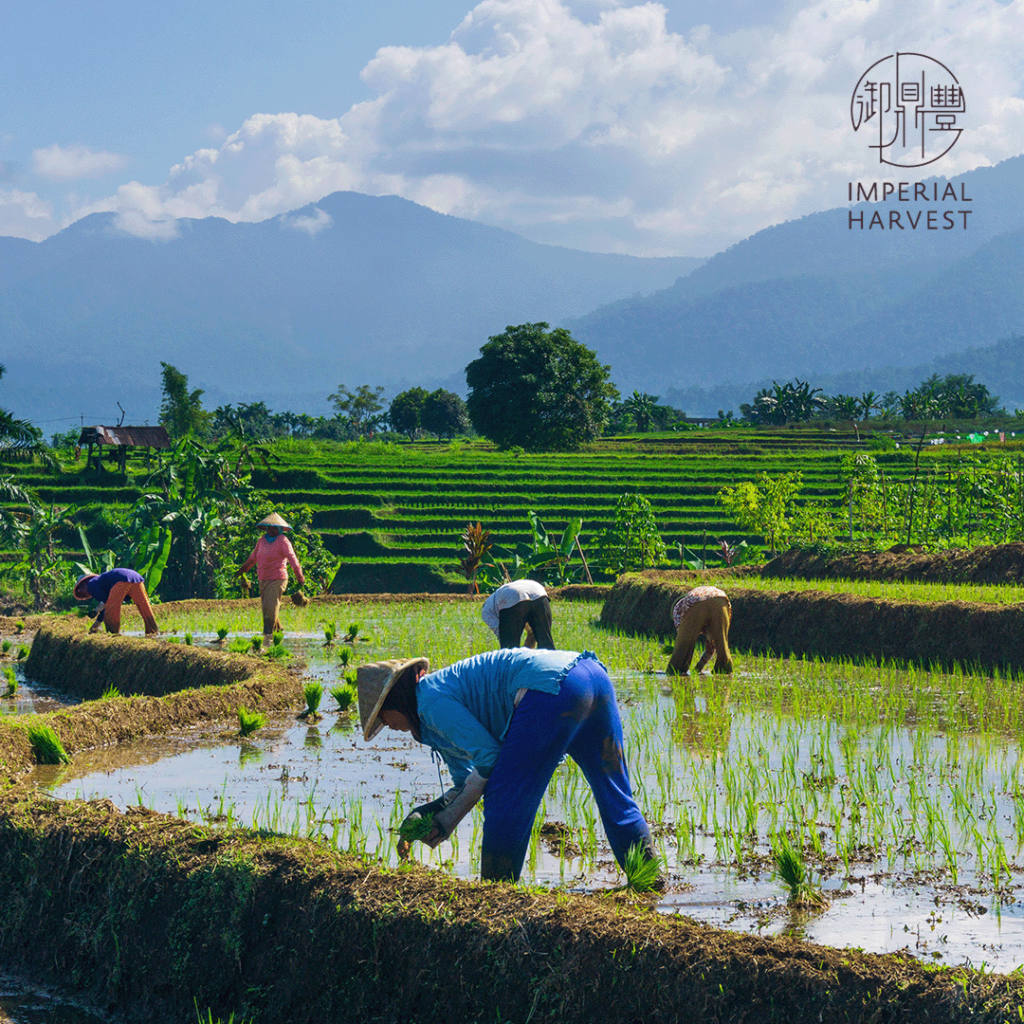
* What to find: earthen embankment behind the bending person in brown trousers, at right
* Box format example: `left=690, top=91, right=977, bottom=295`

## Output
left=600, top=569, right=1024, bottom=672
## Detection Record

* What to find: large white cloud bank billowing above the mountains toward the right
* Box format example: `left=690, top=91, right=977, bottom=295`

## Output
left=48, top=0, right=1024, bottom=254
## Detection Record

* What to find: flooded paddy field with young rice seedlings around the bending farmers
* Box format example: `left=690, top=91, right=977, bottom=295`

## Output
left=9, top=602, right=1024, bottom=972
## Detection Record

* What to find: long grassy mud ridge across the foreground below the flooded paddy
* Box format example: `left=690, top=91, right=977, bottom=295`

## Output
left=0, top=787, right=1024, bottom=1024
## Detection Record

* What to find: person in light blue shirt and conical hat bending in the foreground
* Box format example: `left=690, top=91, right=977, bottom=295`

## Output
left=357, top=647, right=654, bottom=882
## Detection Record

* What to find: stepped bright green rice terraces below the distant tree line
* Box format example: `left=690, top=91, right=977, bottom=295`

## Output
left=4, top=428, right=1021, bottom=596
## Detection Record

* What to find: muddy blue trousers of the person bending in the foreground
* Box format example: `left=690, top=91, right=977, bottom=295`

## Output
left=480, top=658, right=653, bottom=882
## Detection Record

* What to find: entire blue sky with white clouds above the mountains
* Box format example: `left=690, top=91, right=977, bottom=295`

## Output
left=0, top=0, right=1024, bottom=256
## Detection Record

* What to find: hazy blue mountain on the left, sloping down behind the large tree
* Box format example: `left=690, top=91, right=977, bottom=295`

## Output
left=0, top=193, right=701, bottom=420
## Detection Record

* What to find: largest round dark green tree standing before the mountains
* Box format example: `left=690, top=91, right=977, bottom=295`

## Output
left=466, top=324, right=618, bottom=452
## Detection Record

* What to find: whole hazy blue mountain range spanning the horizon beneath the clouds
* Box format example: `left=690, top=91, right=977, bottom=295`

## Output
left=0, top=157, right=1024, bottom=432
